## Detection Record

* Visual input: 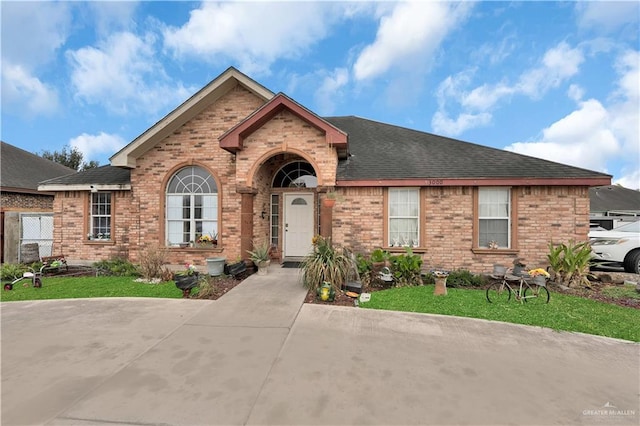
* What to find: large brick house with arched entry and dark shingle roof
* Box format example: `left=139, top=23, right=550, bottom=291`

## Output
left=39, top=68, right=611, bottom=271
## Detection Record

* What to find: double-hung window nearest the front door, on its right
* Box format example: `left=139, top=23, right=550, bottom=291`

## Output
left=388, top=188, right=420, bottom=247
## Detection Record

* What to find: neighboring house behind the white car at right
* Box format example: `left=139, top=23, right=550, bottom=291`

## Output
left=589, top=185, right=640, bottom=229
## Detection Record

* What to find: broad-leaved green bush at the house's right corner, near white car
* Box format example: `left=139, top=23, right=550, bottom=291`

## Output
left=547, top=241, right=592, bottom=287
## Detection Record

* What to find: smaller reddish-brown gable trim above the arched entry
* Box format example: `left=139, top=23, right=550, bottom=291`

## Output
left=219, top=93, right=347, bottom=157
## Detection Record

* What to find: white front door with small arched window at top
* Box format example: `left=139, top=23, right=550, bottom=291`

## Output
left=284, top=194, right=313, bottom=257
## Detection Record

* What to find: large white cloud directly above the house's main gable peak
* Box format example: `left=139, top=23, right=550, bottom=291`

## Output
left=163, top=2, right=342, bottom=74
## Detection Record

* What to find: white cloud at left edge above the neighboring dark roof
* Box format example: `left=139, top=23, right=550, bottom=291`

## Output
left=2, top=61, right=58, bottom=117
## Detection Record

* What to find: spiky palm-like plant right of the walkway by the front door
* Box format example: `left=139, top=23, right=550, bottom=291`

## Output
left=301, top=235, right=356, bottom=292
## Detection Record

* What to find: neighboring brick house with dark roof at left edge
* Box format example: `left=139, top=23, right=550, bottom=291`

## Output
left=0, top=142, right=76, bottom=263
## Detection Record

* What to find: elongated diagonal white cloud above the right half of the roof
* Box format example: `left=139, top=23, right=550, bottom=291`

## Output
left=432, top=42, right=584, bottom=136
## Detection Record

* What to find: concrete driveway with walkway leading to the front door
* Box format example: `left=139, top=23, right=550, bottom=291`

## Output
left=1, top=265, right=640, bottom=425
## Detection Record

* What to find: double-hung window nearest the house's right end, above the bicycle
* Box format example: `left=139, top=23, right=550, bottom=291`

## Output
left=478, top=188, right=511, bottom=248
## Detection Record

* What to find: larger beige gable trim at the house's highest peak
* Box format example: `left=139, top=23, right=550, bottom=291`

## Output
left=109, top=67, right=273, bottom=168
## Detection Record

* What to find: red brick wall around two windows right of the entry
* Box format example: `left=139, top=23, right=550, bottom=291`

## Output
left=333, top=186, right=589, bottom=272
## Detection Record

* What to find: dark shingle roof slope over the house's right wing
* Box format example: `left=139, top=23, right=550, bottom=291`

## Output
left=325, top=116, right=610, bottom=181
